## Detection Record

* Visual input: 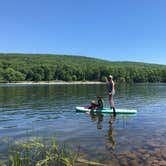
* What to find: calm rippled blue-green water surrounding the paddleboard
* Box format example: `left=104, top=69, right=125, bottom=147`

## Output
left=0, top=84, right=166, bottom=165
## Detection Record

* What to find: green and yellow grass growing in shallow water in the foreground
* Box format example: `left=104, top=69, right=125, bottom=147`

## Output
left=0, top=136, right=102, bottom=166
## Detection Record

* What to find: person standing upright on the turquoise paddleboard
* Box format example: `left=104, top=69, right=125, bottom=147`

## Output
left=105, top=75, right=116, bottom=116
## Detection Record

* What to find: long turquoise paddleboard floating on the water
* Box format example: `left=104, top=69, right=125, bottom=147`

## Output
left=75, top=106, right=137, bottom=114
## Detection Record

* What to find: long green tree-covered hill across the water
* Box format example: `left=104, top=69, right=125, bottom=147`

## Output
left=0, top=54, right=166, bottom=82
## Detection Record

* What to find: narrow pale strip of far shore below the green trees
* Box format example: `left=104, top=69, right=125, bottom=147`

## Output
left=0, top=81, right=104, bottom=85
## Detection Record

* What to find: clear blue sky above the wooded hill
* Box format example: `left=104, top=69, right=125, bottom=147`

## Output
left=0, top=0, right=166, bottom=64
